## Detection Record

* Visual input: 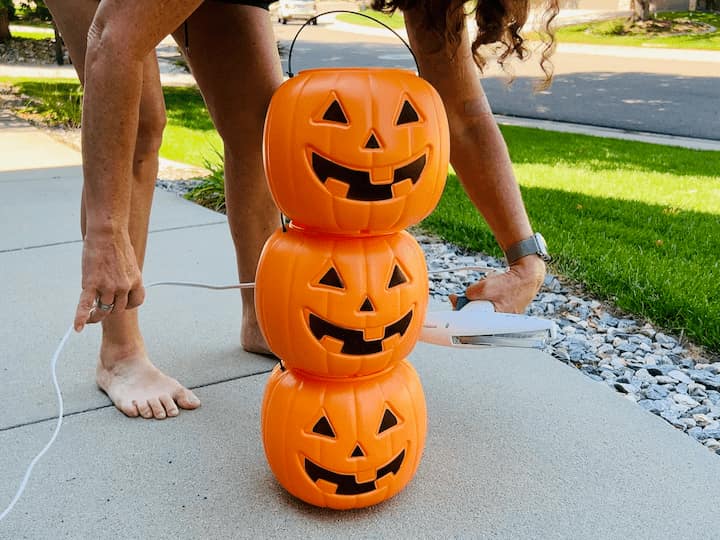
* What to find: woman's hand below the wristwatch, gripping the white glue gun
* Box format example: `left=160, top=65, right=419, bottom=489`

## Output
left=450, top=255, right=545, bottom=313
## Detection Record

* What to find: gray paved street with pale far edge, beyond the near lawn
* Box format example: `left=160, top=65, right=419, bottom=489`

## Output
left=276, top=18, right=720, bottom=140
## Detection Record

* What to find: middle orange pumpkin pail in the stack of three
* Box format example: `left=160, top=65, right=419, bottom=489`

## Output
left=255, top=227, right=428, bottom=377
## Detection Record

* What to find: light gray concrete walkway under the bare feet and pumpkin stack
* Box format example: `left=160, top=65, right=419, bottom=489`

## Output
left=0, top=115, right=720, bottom=540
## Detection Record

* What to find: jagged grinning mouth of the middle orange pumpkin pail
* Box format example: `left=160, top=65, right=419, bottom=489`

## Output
left=308, top=309, right=413, bottom=356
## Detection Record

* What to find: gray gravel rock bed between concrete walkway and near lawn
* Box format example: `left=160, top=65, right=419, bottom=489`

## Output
left=153, top=180, right=720, bottom=455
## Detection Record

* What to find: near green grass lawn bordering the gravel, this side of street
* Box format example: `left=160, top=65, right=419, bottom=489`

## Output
left=2, top=80, right=720, bottom=352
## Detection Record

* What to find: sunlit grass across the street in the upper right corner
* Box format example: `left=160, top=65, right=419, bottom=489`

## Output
left=544, top=11, right=720, bottom=50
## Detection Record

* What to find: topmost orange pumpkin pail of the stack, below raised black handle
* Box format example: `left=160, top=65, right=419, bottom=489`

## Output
left=264, top=68, right=450, bottom=234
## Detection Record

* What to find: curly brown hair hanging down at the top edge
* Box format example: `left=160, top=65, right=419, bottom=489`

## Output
left=371, top=0, right=560, bottom=87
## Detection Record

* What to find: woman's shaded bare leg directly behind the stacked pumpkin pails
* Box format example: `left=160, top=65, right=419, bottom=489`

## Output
left=173, top=1, right=282, bottom=353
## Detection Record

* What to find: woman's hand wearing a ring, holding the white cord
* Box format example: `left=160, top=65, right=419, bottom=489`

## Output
left=75, top=231, right=145, bottom=332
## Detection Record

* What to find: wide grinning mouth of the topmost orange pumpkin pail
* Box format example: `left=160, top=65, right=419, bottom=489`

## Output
left=312, top=152, right=427, bottom=201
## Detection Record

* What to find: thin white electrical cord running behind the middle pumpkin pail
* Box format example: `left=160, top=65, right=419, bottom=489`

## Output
left=0, top=266, right=502, bottom=521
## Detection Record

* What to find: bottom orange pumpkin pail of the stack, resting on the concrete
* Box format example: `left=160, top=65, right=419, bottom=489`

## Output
left=262, top=360, right=427, bottom=509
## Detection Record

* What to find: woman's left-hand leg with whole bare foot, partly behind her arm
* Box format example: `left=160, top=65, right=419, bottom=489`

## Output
left=47, top=0, right=199, bottom=418
